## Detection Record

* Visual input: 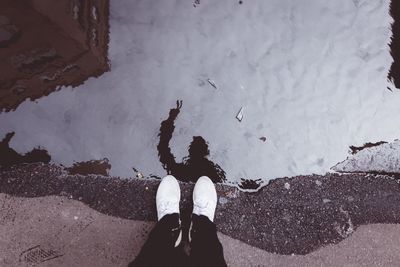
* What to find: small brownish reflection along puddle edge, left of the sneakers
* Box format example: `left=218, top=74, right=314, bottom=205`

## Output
left=66, top=158, right=111, bottom=176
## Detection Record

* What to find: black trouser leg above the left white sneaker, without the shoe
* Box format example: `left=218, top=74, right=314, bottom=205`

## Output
left=129, top=213, right=184, bottom=267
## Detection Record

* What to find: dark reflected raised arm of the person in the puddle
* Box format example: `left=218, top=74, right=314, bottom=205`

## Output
left=157, top=100, right=182, bottom=171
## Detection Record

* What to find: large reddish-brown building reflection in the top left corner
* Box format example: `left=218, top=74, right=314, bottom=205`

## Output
left=0, top=0, right=110, bottom=112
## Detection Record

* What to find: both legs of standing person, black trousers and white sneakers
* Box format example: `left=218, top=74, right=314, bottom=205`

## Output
left=129, top=175, right=227, bottom=267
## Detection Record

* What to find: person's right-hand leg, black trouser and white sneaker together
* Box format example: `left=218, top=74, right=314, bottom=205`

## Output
left=189, top=176, right=227, bottom=267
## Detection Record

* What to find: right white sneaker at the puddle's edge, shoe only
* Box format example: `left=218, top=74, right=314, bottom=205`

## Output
left=193, top=176, right=217, bottom=221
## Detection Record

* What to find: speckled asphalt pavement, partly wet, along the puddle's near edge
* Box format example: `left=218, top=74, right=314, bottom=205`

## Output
left=0, top=163, right=400, bottom=266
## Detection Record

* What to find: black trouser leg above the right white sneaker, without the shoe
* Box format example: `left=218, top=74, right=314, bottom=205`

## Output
left=190, top=214, right=227, bottom=267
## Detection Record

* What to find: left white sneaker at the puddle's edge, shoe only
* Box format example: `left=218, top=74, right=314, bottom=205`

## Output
left=156, top=175, right=181, bottom=220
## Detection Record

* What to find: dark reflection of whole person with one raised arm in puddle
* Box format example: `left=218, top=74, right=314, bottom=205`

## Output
left=157, top=101, right=226, bottom=183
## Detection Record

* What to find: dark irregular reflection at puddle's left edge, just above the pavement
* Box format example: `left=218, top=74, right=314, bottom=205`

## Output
left=0, top=132, right=51, bottom=168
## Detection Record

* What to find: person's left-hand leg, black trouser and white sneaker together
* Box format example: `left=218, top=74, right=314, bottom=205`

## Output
left=129, top=175, right=183, bottom=267
